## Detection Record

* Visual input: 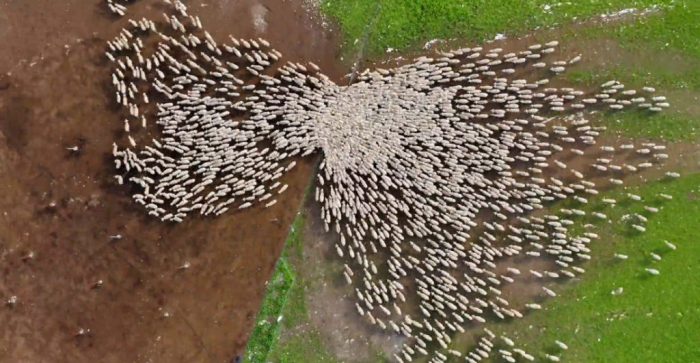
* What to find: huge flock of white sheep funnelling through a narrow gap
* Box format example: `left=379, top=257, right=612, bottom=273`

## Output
left=106, top=0, right=677, bottom=362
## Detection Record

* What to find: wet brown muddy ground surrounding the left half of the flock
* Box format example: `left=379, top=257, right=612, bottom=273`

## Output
left=0, top=0, right=346, bottom=363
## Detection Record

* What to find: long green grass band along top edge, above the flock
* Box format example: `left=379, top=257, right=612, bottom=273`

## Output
left=323, top=0, right=673, bottom=56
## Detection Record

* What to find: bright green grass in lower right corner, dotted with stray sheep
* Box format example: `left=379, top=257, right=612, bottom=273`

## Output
left=490, top=174, right=700, bottom=363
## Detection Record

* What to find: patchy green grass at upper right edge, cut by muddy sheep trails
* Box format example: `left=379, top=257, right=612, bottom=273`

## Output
left=567, top=1, right=700, bottom=141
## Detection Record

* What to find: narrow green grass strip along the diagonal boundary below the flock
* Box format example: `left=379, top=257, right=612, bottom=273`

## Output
left=245, top=215, right=304, bottom=363
